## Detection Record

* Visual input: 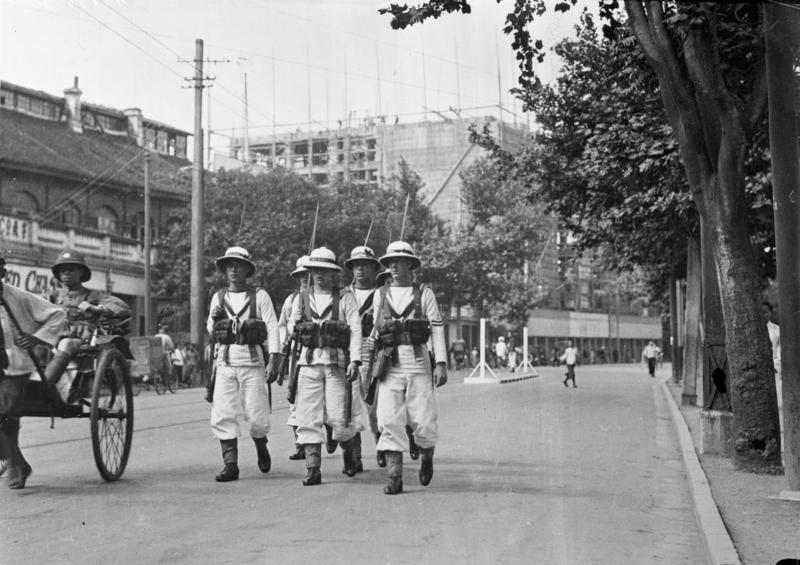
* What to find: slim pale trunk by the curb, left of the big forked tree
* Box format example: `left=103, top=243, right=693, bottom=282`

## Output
left=681, top=237, right=703, bottom=406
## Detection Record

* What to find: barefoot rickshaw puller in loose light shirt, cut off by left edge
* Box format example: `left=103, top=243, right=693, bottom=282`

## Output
left=0, top=257, right=67, bottom=489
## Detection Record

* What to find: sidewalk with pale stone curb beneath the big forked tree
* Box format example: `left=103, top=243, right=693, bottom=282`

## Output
left=659, top=372, right=800, bottom=565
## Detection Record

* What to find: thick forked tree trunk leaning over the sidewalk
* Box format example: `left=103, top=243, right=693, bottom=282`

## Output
left=625, top=0, right=780, bottom=470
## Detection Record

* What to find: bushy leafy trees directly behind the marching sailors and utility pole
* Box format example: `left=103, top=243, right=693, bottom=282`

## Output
left=153, top=162, right=445, bottom=324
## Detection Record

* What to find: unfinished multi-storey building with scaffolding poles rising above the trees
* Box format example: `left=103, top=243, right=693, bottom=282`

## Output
left=214, top=112, right=528, bottom=224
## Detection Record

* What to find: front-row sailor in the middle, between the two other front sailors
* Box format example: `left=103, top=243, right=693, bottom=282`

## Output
left=287, top=247, right=361, bottom=486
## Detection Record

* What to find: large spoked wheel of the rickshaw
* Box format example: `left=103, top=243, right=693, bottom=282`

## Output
left=89, top=347, right=133, bottom=481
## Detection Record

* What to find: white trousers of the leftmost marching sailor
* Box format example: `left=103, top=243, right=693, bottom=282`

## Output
left=211, top=365, right=270, bottom=439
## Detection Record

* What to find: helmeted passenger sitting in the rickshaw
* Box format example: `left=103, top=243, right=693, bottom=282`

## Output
left=44, top=250, right=131, bottom=402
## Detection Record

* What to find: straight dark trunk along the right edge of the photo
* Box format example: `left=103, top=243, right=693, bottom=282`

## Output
left=764, top=3, right=800, bottom=484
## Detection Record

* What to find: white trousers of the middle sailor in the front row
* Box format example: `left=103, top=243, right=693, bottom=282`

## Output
left=295, top=365, right=364, bottom=444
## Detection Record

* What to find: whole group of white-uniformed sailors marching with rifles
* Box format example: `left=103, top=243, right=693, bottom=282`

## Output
left=207, top=241, right=447, bottom=494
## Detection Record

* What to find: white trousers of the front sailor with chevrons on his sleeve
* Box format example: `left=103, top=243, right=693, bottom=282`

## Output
left=376, top=367, right=439, bottom=451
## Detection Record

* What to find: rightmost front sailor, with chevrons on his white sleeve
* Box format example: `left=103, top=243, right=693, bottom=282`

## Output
left=369, top=241, right=447, bottom=495
